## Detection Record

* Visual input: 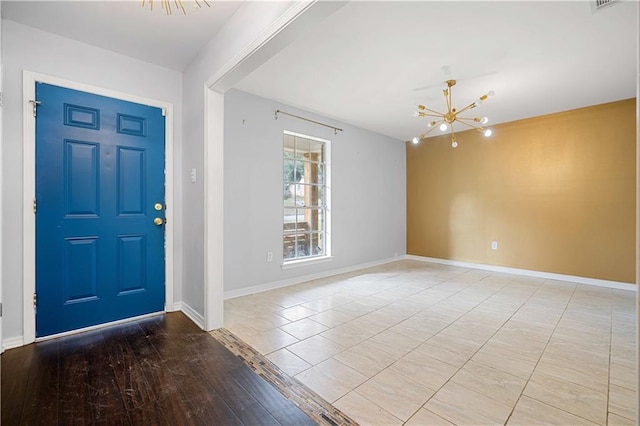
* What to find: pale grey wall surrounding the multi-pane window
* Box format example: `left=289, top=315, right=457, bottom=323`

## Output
left=223, top=90, right=406, bottom=293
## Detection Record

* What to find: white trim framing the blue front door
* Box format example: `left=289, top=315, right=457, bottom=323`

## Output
left=22, top=70, right=175, bottom=345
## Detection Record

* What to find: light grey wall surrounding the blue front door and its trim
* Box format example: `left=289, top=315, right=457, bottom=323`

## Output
left=2, top=20, right=183, bottom=339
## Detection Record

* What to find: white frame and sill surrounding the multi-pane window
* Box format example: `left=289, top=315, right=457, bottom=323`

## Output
left=280, top=130, right=333, bottom=269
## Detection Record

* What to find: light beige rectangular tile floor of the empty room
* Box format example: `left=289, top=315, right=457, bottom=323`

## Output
left=225, top=261, right=637, bottom=425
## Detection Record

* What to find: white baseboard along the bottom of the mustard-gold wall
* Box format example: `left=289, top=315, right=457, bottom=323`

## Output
left=404, top=254, right=637, bottom=291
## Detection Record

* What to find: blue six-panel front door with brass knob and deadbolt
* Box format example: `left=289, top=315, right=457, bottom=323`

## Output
left=35, top=83, right=165, bottom=337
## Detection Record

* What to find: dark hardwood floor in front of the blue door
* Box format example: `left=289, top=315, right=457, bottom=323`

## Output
left=0, top=312, right=315, bottom=426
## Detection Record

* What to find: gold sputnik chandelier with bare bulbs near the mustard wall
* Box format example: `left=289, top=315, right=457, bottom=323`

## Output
left=411, top=80, right=494, bottom=148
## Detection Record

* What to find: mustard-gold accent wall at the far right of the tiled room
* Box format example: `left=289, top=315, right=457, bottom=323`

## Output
left=406, top=99, right=636, bottom=283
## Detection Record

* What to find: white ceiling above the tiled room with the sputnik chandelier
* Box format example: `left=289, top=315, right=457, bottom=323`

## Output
left=237, top=1, right=638, bottom=140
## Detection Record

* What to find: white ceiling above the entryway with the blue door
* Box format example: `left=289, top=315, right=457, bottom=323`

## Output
left=2, top=0, right=242, bottom=71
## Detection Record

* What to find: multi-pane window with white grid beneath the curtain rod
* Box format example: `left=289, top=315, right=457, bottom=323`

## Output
left=282, top=131, right=330, bottom=263
